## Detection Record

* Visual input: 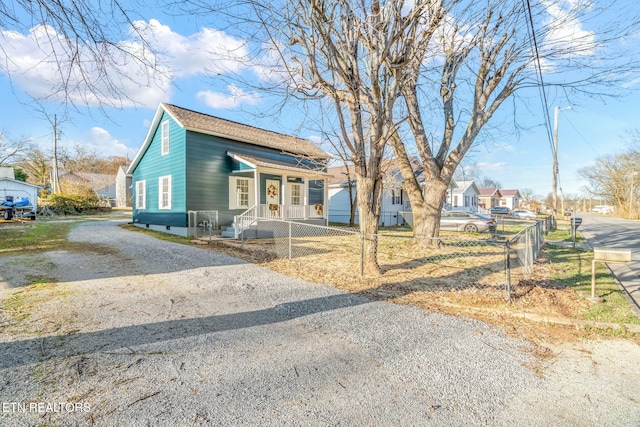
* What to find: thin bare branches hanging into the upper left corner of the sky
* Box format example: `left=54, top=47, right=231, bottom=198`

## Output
left=0, top=0, right=165, bottom=107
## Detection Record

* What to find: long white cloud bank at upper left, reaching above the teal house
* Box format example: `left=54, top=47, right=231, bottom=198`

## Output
left=0, top=19, right=258, bottom=108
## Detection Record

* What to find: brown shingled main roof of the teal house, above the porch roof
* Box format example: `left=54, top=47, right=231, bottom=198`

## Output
left=162, top=103, right=331, bottom=159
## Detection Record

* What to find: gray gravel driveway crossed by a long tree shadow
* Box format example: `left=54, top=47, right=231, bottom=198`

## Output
left=0, top=221, right=640, bottom=426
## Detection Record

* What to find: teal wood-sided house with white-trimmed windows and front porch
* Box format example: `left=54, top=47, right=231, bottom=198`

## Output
left=127, top=103, right=330, bottom=238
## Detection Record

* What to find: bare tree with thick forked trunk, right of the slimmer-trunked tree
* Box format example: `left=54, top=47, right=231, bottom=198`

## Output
left=392, top=0, right=638, bottom=241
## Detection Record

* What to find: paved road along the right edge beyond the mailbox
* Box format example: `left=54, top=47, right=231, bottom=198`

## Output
left=578, top=214, right=640, bottom=315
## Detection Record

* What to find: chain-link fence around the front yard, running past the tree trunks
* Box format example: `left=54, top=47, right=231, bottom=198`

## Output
left=214, top=219, right=553, bottom=301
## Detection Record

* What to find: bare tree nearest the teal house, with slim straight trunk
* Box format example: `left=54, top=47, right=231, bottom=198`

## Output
left=188, top=0, right=442, bottom=275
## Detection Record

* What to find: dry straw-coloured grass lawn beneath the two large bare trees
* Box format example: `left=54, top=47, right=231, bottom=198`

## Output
left=198, top=233, right=624, bottom=341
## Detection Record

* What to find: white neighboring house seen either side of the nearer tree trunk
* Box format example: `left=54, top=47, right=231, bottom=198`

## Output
left=327, top=166, right=411, bottom=226
